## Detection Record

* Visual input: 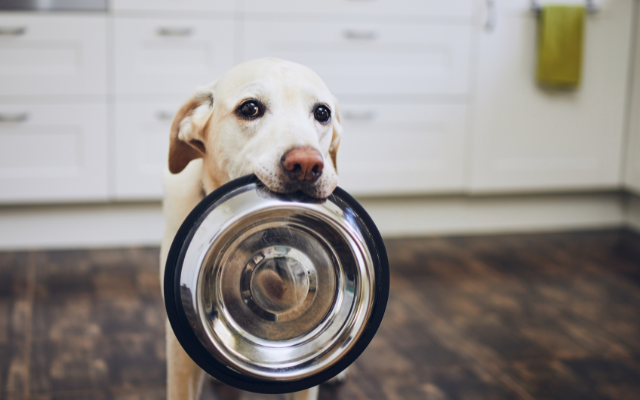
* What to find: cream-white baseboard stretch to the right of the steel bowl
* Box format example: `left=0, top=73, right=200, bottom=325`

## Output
left=362, top=193, right=624, bottom=237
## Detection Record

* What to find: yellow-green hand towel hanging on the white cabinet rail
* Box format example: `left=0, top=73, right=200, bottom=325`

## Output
left=536, top=5, right=586, bottom=89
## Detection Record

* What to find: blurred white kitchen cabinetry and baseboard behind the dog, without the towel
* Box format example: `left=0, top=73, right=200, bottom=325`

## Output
left=0, top=0, right=640, bottom=244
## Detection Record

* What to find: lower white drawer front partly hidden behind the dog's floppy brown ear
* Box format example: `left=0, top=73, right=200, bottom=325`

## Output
left=115, top=102, right=181, bottom=199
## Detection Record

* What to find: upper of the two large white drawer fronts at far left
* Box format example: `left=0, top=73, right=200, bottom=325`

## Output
left=0, top=13, right=107, bottom=96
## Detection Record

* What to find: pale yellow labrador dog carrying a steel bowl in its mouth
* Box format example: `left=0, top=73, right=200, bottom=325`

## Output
left=160, top=58, right=341, bottom=400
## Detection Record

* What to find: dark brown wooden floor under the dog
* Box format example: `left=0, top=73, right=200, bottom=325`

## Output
left=0, top=231, right=640, bottom=400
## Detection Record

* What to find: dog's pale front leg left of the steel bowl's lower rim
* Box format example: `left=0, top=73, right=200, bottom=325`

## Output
left=166, top=321, right=204, bottom=400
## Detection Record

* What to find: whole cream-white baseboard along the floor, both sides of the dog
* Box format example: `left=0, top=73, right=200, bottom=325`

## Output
left=0, top=193, right=640, bottom=250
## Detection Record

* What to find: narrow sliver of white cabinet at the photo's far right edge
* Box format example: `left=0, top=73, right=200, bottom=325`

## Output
left=625, top=3, right=640, bottom=195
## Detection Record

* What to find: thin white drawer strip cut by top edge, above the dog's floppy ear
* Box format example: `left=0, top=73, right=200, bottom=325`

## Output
left=111, top=0, right=234, bottom=12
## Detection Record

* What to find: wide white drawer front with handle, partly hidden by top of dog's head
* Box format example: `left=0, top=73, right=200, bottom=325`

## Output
left=244, top=21, right=471, bottom=95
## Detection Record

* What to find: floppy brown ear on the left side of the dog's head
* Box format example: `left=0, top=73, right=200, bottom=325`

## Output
left=169, top=90, right=213, bottom=174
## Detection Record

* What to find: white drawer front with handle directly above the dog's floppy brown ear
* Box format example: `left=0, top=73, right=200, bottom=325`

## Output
left=115, top=18, right=234, bottom=96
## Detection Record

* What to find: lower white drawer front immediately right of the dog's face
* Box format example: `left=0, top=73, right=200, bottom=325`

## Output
left=338, top=105, right=467, bottom=194
